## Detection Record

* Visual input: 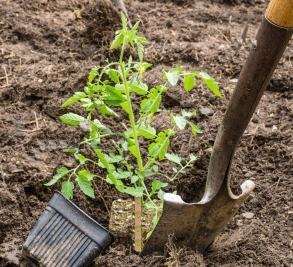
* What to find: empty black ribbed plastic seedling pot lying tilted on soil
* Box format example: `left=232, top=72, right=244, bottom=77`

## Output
left=22, top=192, right=114, bottom=267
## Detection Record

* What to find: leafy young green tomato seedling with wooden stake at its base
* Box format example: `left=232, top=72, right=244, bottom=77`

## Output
left=46, top=13, right=221, bottom=251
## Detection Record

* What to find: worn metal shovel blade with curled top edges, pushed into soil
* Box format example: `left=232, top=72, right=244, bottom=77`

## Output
left=141, top=177, right=254, bottom=255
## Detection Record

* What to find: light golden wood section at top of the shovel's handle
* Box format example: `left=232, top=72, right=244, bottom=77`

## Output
left=266, top=0, right=293, bottom=28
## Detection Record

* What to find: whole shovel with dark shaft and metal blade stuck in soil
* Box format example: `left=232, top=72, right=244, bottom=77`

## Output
left=141, top=0, right=293, bottom=256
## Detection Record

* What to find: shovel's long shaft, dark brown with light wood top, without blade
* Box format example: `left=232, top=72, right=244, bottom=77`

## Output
left=200, top=0, right=293, bottom=204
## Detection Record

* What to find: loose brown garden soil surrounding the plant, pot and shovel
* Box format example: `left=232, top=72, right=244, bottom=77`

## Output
left=0, top=0, right=293, bottom=266
